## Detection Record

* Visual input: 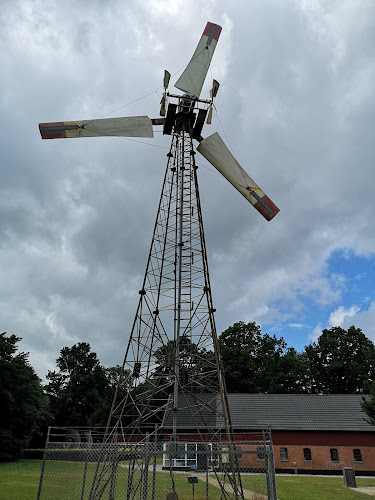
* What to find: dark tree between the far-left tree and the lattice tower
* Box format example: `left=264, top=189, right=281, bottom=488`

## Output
left=45, top=342, right=111, bottom=426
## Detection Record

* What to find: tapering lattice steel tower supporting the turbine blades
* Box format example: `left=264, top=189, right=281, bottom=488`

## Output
left=92, top=96, right=248, bottom=498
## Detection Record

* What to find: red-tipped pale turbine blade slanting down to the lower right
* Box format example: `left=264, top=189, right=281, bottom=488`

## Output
left=197, top=132, right=279, bottom=220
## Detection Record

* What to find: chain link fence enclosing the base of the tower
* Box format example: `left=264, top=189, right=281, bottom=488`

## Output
left=38, top=428, right=277, bottom=500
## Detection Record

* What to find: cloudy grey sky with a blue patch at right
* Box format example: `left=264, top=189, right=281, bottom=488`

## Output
left=0, top=0, right=375, bottom=378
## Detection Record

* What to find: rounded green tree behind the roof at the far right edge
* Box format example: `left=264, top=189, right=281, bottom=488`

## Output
left=305, top=326, right=375, bottom=394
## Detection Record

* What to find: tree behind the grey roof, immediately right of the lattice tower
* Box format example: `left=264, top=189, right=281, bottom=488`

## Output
left=219, top=321, right=308, bottom=393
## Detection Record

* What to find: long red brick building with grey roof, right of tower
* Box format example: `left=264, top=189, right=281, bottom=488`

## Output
left=228, top=394, right=375, bottom=475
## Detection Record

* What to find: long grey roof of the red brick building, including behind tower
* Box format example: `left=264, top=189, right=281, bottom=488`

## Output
left=166, top=394, right=375, bottom=432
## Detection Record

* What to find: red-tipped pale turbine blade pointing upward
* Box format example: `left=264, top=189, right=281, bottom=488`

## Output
left=174, top=23, right=221, bottom=98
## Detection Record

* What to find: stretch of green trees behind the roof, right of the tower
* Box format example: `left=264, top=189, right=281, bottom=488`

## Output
left=219, top=322, right=375, bottom=396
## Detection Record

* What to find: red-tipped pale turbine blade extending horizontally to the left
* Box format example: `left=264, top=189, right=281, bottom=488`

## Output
left=39, top=116, right=154, bottom=139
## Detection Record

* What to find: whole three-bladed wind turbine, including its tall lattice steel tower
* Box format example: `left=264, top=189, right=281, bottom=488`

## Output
left=39, top=22, right=279, bottom=499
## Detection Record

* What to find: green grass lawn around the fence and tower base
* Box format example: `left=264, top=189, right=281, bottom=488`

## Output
left=0, top=460, right=375, bottom=500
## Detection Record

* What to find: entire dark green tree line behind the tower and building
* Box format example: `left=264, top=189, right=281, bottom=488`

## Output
left=0, top=322, right=375, bottom=461
